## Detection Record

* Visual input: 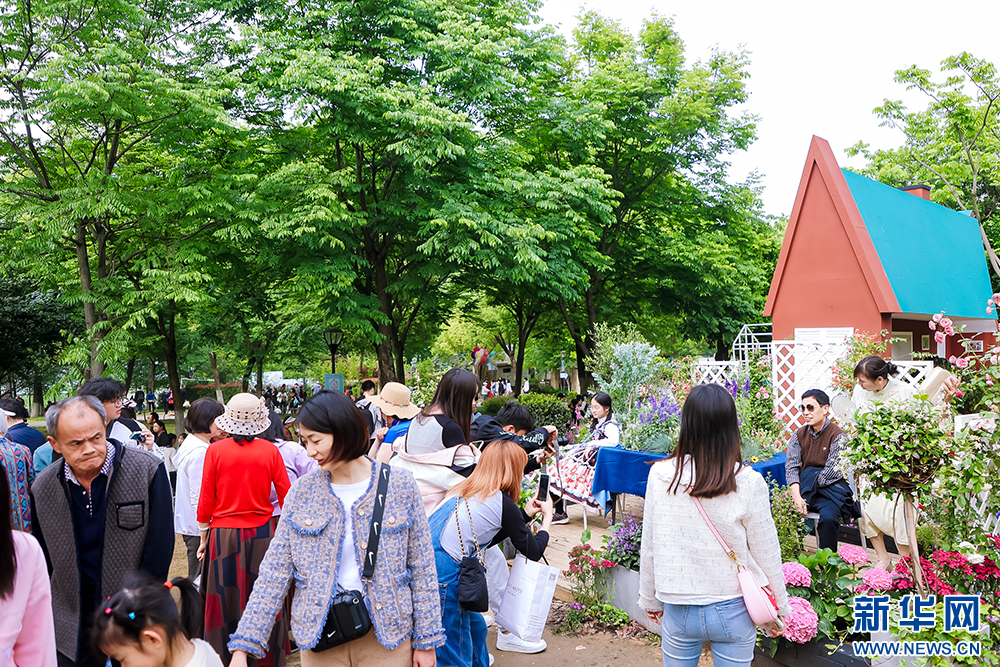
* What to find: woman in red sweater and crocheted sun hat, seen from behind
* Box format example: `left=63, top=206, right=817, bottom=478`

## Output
left=198, top=394, right=290, bottom=667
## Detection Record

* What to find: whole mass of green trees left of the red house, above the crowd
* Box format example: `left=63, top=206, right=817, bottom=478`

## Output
left=0, top=0, right=777, bottom=402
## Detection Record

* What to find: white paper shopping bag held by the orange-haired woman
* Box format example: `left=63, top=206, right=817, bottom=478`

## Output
left=497, top=554, right=559, bottom=642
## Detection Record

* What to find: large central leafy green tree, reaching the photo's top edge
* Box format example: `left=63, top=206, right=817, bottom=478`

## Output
left=229, top=0, right=608, bottom=382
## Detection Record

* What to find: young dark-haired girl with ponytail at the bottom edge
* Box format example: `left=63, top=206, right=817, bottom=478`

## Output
left=91, top=574, right=222, bottom=667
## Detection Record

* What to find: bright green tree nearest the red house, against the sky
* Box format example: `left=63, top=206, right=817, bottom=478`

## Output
left=532, top=12, right=758, bottom=385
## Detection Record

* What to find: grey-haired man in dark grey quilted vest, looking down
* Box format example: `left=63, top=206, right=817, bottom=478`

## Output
left=31, top=396, right=174, bottom=667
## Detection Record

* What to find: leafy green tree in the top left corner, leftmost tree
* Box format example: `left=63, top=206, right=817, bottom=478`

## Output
left=0, top=0, right=236, bottom=376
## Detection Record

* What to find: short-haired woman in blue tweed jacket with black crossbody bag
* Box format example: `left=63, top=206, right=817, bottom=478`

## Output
left=228, top=392, right=445, bottom=667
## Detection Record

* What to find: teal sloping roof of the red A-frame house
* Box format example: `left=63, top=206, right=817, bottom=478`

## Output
left=841, top=169, right=995, bottom=318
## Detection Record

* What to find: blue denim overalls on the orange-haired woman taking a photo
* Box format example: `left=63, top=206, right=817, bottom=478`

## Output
left=429, top=502, right=490, bottom=667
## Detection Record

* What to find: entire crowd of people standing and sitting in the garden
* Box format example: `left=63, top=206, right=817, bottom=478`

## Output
left=0, top=359, right=936, bottom=667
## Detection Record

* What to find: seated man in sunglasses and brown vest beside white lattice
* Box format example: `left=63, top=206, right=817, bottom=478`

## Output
left=785, top=389, right=861, bottom=551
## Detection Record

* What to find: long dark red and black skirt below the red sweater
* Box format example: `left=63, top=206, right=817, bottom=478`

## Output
left=201, top=521, right=291, bottom=667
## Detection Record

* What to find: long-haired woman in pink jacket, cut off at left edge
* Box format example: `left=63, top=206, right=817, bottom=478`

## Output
left=0, top=466, right=56, bottom=667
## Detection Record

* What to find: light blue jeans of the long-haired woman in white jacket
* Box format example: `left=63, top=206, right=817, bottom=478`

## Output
left=660, top=598, right=757, bottom=667
